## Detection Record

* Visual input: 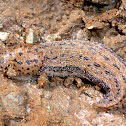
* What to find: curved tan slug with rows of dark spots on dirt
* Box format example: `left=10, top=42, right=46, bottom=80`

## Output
left=0, top=40, right=126, bottom=108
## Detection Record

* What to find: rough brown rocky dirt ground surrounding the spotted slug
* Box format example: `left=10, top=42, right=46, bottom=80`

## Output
left=0, top=0, right=126, bottom=126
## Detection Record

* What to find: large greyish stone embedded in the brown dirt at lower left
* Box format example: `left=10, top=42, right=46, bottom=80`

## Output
left=1, top=91, right=25, bottom=117
